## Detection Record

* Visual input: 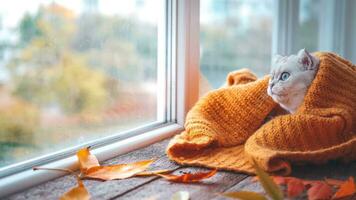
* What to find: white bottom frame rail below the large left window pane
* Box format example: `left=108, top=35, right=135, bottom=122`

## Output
left=0, top=124, right=183, bottom=197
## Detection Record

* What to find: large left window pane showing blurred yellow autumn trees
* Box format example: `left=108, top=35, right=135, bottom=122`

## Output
left=0, top=0, right=164, bottom=167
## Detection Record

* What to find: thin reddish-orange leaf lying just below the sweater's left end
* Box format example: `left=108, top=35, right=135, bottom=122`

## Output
left=157, top=169, right=217, bottom=183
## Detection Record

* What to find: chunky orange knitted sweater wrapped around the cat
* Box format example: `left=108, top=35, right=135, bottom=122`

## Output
left=167, top=52, right=356, bottom=174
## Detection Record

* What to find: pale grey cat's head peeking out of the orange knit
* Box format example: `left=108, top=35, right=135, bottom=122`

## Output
left=267, top=49, right=320, bottom=114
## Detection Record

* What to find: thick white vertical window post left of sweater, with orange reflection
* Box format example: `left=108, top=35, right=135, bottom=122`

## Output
left=173, top=0, right=200, bottom=126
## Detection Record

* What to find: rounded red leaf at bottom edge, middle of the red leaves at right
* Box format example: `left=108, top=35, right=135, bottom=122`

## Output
left=308, top=181, right=333, bottom=200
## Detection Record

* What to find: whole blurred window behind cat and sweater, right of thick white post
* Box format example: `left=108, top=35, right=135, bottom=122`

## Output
left=200, top=0, right=356, bottom=96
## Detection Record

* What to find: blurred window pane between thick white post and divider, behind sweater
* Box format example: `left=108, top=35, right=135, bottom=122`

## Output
left=200, top=0, right=273, bottom=94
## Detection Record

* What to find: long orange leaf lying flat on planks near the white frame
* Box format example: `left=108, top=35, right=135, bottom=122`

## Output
left=83, top=160, right=154, bottom=181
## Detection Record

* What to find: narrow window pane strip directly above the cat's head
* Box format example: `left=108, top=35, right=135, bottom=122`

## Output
left=295, top=0, right=321, bottom=52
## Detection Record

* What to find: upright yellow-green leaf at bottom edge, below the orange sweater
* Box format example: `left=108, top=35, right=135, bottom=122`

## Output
left=253, top=161, right=283, bottom=200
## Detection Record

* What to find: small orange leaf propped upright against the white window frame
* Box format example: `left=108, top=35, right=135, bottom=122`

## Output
left=77, top=147, right=100, bottom=173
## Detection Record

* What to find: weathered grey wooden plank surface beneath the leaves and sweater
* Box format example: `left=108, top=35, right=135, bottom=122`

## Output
left=5, top=140, right=356, bottom=200
